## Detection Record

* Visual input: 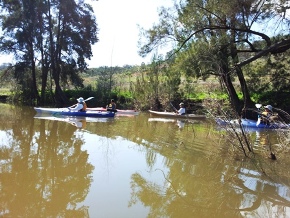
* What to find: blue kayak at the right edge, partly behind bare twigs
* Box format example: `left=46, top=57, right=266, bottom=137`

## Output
left=216, top=118, right=290, bottom=129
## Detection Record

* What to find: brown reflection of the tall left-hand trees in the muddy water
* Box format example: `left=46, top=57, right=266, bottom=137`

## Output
left=0, top=105, right=93, bottom=217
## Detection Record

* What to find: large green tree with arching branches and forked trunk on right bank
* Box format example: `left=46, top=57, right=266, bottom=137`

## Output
left=139, top=0, right=290, bottom=112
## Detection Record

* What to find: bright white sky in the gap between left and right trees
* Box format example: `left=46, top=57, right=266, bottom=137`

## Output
left=0, top=0, right=172, bottom=68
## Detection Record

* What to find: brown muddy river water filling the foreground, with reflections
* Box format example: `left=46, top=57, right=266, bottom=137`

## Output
left=0, top=104, right=290, bottom=218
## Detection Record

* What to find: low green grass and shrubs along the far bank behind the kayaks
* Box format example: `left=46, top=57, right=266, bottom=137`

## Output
left=0, top=65, right=290, bottom=114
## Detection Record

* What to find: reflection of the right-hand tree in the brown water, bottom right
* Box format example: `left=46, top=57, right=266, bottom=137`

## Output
left=130, top=152, right=290, bottom=217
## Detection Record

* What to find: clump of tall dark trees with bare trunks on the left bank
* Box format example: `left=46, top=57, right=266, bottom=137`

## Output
left=0, top=0, right=98, bottom=103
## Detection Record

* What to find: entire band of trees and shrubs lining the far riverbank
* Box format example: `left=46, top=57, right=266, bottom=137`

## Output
left=0, top=0, right=290, bottom=113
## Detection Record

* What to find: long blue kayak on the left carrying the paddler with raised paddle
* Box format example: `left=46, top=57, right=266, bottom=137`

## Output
left=34, top=107, right=115, bottom=118
